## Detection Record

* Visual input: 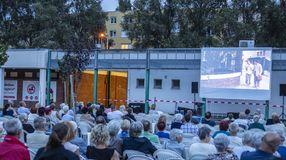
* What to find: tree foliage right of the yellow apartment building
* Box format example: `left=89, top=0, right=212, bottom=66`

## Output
left=122, top=0, right=286, bottom=48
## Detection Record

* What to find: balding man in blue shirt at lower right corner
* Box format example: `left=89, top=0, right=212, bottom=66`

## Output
left=240, top=132, right=281, bottom=160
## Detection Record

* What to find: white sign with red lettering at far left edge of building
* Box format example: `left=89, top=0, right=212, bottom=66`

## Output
left=4, top=80, right=18, bottom=100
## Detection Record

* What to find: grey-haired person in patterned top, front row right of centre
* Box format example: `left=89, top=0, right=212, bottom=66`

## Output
left=208, top=134, right=238, bottom=160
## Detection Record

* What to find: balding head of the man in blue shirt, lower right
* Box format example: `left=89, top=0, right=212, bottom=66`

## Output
left=260, top=132, right=281, bottom=153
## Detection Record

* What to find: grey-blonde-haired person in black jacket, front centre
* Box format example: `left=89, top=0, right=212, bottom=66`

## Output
left=123, top=121, right=157, bottom=155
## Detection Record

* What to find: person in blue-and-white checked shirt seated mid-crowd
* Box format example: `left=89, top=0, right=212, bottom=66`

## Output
left=181, top=113, right=199, bottom=135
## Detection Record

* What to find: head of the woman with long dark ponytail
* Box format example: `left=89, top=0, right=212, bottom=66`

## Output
left=46, top=123, right=68, bottom=149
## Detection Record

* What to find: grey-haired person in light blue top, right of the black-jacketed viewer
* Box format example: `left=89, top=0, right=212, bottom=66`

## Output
left=165, top=129, right=186, bottom=158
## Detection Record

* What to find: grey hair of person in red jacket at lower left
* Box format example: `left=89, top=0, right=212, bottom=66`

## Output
left=3, top=118, right=23, bottom=136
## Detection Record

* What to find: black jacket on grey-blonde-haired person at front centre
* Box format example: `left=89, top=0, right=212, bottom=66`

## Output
left=123, top=137, right=157, bottom=155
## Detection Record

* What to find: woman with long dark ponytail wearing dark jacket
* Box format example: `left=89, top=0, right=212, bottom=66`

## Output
left=35, top=123, right=79, bottom=160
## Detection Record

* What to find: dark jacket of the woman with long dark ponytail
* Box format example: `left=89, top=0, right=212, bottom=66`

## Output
left=34, top=146, right=79, bottom=160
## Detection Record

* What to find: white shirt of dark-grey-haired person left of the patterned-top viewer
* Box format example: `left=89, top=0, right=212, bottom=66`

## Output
left=189, top=142, right=217, bottom=160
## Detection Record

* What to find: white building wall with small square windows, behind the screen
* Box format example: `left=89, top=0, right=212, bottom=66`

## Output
left=127, top=69, right=286, bottom=115
